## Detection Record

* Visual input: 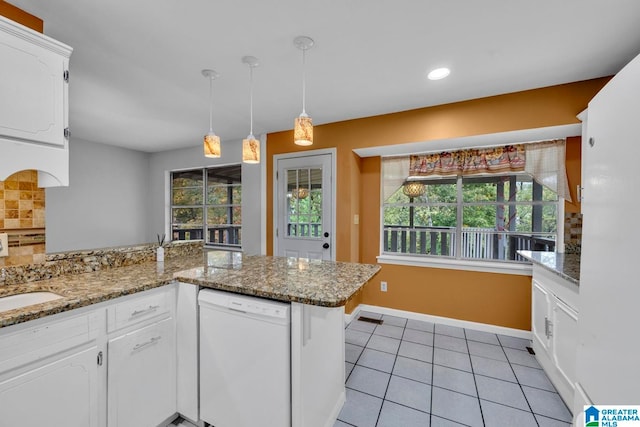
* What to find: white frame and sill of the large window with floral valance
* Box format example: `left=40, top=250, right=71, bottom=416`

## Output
left=377, top=173, right=564, bottom=275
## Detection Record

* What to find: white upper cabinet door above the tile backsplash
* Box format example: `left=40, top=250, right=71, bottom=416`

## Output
left=0, top=24, right=68, bottom=146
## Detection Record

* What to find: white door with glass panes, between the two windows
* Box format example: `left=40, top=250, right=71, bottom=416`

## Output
left=274, top=153, right=335, bottom=260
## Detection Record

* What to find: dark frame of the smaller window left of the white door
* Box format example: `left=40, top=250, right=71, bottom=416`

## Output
left=169, top=163, right=242, bottom=251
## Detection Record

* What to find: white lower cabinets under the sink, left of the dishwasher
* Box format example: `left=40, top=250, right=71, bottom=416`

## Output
left=0, top=284, right=177, bottom=427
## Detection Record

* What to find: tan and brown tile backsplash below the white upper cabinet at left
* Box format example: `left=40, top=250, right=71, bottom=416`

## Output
left=0, top=170, right=45, bottom=266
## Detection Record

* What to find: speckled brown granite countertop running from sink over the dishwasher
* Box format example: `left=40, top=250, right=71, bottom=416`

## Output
left=0, top=251, right=380, bottom=328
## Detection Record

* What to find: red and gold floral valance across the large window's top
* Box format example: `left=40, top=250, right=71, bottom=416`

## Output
left=409, top=144, right=526, bottom=176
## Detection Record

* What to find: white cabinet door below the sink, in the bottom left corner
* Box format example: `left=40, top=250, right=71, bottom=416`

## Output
left=0, top=347, right=99, bottom=427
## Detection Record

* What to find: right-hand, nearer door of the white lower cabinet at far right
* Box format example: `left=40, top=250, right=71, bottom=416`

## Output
left=552, top=299, right=578, bottom=390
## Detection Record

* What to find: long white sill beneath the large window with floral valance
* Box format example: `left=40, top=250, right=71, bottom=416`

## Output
left=377, top=254, right=532, bottom=276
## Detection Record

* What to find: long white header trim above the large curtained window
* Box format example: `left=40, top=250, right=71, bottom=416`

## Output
left=353, top=123, right=582, bottom=157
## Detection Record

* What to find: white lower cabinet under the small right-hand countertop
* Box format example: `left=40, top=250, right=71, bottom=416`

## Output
left=531, top=265, right=578, bottom=408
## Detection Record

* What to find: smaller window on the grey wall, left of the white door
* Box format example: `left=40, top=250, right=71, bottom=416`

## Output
left=171, top=165, right=242, bottom=248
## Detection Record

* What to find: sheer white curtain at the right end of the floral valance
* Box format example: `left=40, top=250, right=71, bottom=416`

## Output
left=524, top=139, right=571, bottom=201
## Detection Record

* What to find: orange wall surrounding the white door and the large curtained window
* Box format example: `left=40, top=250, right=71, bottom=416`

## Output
left=266, top=78, right=609, bottom=330
